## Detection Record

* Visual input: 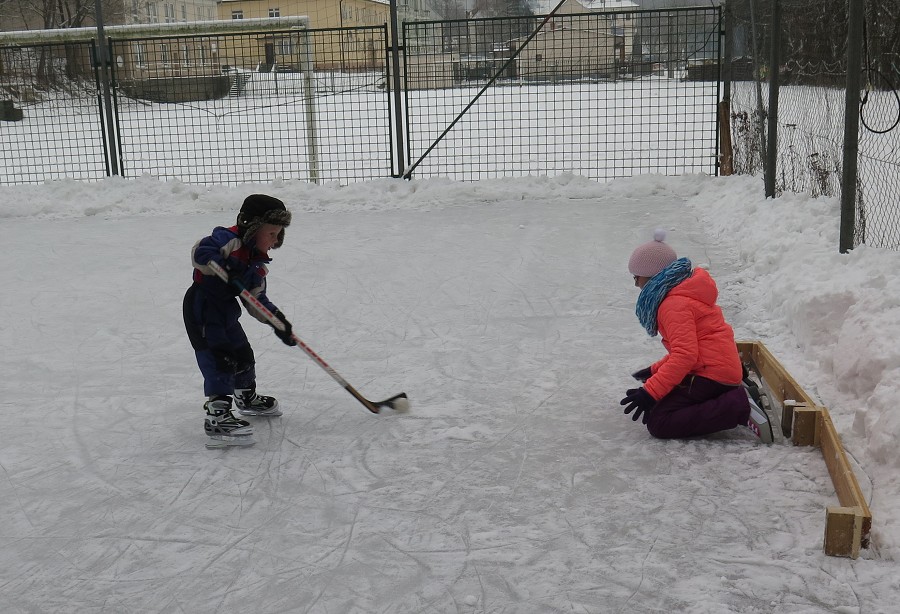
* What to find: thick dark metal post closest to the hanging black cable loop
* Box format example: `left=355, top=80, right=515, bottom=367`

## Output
left=840, top=0, right=864, bottom=254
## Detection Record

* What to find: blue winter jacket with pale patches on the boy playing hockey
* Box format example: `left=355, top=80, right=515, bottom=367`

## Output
left=191, top=226, right=278, bottom=323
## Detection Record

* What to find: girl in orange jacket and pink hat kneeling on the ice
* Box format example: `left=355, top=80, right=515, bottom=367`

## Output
left=621, top=230, right=771, bottom=441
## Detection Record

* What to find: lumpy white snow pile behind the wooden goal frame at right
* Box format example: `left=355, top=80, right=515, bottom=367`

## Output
left=691, top=178, right=900, bottom=559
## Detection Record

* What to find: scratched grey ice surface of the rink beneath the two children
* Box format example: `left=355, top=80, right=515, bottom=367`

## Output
left=0, top=194, right=897, bottom=614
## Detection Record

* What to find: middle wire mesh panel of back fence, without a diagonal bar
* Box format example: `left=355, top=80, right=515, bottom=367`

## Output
left=111, top=27, right=392, bottom=183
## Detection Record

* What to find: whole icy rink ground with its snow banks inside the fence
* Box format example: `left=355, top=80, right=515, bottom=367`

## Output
left=0, top=175, right=900, bottom=614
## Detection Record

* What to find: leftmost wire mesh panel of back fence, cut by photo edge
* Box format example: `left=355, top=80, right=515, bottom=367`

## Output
left=0, top=42, right=109, bottom=184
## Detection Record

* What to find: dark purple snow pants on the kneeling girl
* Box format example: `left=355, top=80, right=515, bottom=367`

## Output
left=647, top=375, right=750, bottom=439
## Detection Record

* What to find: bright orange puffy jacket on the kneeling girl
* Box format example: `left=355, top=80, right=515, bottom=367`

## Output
left=644, top=269, right=743, bottom=401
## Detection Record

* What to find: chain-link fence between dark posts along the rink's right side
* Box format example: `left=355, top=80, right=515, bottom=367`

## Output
left=726, top=0, right=900, bottom=249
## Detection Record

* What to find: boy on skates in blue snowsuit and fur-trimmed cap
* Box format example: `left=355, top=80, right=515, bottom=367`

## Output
left=184, top=194, right=296, bottom=441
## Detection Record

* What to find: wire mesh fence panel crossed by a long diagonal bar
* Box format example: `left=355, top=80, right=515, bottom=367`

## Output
left=404, top=7, right=721, bottom=179
